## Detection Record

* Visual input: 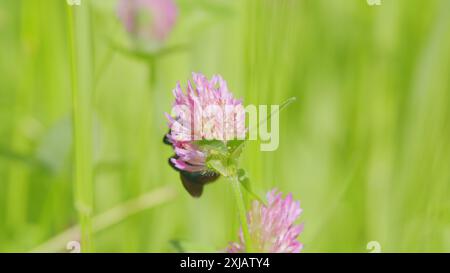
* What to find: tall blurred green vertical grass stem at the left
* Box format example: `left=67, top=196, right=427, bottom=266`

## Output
left=67, top=5, right=93, bottom=252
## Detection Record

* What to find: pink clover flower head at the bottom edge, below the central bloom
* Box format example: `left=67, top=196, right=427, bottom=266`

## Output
left=226, top=190, right=303, bottom=253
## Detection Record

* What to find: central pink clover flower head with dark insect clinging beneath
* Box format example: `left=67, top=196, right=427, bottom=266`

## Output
left=165, top=73, right=245, bottom=173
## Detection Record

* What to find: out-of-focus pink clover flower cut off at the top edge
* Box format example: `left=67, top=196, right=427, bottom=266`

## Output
left=118, top=0, right=178, bottom=42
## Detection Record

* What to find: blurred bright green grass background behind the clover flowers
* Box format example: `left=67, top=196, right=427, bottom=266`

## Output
left=0, top=0, right=450, bottom=252
